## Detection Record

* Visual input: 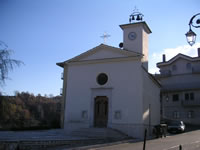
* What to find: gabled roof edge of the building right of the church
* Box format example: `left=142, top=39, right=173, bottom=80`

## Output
left=156, top=53, right=200, bottom=68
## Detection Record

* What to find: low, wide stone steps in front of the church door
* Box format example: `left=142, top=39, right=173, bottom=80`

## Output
left=70, top=128, right=128, bottom=139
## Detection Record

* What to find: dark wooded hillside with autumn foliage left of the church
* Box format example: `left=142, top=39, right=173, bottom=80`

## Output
left=0, top=92, right=61, bottom=130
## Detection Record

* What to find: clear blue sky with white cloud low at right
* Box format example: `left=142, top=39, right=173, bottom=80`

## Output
left=0, top=0, right=200, bottom=95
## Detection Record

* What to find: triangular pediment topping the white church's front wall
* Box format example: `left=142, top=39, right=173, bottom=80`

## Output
left=58, top=44, right=142, bottom=67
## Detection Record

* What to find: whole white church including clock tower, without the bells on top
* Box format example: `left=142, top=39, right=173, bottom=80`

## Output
left=57, top=22, right=160, bottom=138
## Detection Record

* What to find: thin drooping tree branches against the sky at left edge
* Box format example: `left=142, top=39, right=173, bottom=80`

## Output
left=0, top=41, right=23, bottom=86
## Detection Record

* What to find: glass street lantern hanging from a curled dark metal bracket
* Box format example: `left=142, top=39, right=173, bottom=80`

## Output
left=185, top=13, right=200, bottom=46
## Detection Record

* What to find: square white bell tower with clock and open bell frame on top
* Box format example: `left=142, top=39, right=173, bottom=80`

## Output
left=120, top=11, right=151, bottom=70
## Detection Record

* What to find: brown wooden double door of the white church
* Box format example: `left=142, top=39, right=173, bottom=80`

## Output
left=94, top=96, right=108, bottom=128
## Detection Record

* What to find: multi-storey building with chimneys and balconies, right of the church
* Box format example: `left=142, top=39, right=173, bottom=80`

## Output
left=156, top=48, right=200, bottom=125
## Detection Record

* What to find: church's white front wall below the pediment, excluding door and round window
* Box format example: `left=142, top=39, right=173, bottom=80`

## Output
left=65, top=61, right=148, bottom=137
